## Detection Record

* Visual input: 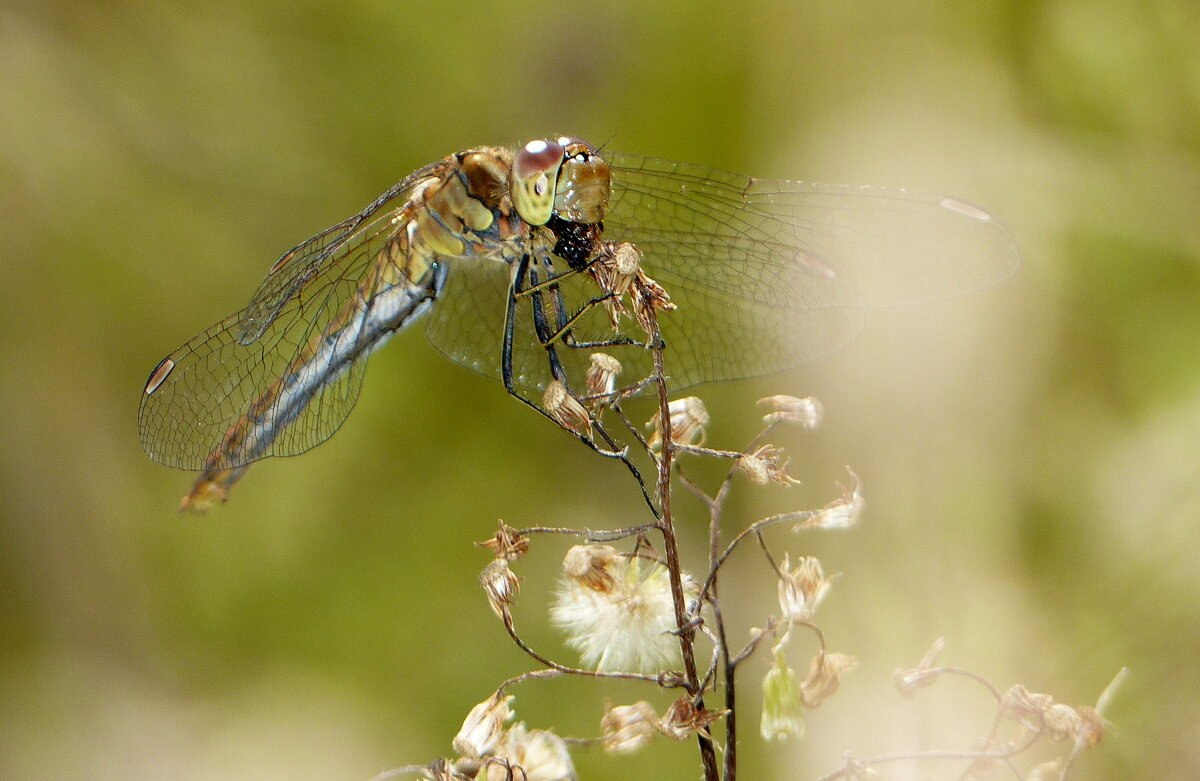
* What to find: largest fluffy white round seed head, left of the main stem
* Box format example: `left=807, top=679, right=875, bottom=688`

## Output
left=551, top=546, right=696, bottom=672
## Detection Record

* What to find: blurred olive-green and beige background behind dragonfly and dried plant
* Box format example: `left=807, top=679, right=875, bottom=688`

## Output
left=0, top=0, right=1200, bottom=780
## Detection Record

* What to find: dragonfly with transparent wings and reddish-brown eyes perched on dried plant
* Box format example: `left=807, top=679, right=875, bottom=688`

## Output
left=138, top=137, right=1019, bottom=510
